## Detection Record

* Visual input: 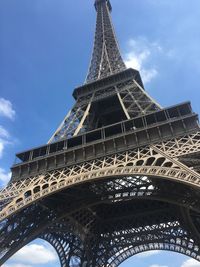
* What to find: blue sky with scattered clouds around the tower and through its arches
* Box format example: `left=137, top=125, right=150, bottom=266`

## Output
left=0, top=0, right=200, bottom=267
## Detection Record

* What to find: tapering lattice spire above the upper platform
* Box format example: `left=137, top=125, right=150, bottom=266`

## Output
left=86, top=0, right=126, bottom=83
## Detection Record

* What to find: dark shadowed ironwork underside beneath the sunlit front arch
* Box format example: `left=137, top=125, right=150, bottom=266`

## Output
left=0, top=176, right=200, bottom=267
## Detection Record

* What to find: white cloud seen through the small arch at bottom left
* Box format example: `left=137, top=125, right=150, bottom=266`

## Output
left=11, top=244, right=57, bottom=265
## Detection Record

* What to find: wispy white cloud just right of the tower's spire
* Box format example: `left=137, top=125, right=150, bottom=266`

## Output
left=125, top=38, right=162, bottom=83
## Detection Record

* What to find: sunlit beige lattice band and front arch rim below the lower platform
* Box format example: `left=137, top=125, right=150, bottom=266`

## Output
left=0, top=133, right=200, bottom=219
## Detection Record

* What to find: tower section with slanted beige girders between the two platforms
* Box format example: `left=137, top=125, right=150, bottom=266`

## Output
left=49, top=75, right=161, bottom=143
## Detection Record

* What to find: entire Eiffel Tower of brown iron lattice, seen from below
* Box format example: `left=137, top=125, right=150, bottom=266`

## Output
left=0, top=0, right=200, bottom=267
